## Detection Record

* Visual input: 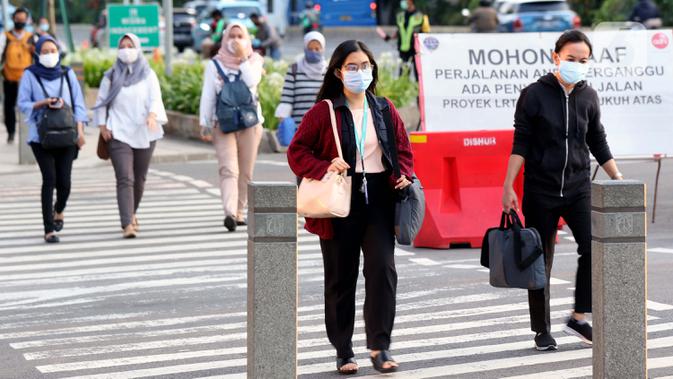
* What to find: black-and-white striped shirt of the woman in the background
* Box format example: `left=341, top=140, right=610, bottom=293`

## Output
left=276, top=65, right=323, bottom=125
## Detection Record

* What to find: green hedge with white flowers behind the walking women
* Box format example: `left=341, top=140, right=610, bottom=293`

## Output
left=77, top=50, right=418, bottom=129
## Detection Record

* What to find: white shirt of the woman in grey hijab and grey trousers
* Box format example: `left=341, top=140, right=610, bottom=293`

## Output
left=94, top=71, right=168, bottom=149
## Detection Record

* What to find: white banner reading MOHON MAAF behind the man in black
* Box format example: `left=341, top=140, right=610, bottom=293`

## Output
left=418, top=30, right=673, bottom=156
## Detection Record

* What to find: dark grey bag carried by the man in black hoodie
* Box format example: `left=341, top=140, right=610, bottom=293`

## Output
left=481, top=211, right=547, bottom=290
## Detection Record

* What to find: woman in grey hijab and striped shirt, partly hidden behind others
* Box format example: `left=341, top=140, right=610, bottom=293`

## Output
left=276, top=31, right=327, bottom=125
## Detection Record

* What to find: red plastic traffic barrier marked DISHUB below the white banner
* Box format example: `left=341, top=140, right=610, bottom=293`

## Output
left=410, top=130, right=523, bottom=249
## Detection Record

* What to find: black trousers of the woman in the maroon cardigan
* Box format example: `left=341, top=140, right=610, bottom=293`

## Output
left=320, top=173, right=397, bottom=358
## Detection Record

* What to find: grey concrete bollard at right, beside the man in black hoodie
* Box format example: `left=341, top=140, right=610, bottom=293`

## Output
left=591, top=180, right=647, bottom=379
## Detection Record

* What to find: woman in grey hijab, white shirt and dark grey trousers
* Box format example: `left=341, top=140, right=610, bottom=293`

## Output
left=94, top=33, right=168, bottom=238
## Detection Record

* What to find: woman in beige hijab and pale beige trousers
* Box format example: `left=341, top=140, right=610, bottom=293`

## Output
left=199, top=22, right=264, bottom=232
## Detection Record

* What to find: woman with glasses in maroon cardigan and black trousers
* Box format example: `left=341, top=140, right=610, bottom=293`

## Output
left=287, top=40, right=413, bottom=374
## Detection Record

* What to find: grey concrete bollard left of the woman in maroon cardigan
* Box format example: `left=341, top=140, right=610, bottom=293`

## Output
left=247, top=182, right=298, bottom=379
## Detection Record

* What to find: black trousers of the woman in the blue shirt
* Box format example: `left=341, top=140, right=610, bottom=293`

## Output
left=30, top=142, right=78, bottom=234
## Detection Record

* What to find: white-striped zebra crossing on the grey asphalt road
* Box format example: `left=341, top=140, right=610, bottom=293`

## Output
left=0, top=168, right=673, bottom=379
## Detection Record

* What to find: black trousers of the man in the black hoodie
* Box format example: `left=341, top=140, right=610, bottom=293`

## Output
left=523, top=189, right=591, bottom=333
